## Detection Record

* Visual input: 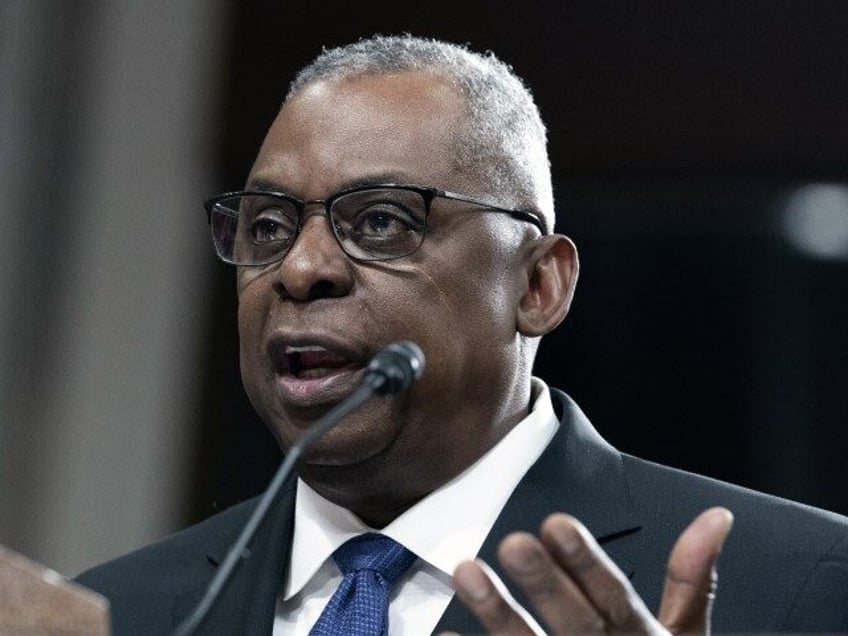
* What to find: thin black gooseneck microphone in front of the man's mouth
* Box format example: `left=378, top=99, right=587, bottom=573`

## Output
left=173, top=340, right=424, bottom=636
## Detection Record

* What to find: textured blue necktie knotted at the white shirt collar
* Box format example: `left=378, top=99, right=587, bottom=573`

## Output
left=309, top=533, right=416, bottom=636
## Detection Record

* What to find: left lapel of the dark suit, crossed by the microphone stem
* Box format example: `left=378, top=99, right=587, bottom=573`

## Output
left=173, top=477, right=296, bottom=636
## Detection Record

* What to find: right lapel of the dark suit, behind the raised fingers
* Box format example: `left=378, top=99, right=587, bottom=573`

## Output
left=435, top=389, right=640, bottom=633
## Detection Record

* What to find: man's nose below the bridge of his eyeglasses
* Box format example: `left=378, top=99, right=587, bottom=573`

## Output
left=274, top=210, right=353, bottom=300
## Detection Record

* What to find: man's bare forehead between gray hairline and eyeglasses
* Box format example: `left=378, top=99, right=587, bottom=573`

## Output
left=250, top=72, right=469, bottom=198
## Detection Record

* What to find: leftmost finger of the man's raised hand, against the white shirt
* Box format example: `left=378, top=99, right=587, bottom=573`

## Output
left=453, top=561, right=543, bottom=636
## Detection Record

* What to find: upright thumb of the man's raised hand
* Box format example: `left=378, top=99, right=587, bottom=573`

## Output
left=659, top=508, right=733, bottom=634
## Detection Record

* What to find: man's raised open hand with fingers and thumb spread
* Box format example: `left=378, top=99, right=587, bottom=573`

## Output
left=453, top=508, right=733, bottom=634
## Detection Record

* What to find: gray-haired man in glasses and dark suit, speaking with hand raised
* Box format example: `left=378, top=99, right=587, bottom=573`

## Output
left=80, top=37, right=848, bottom=635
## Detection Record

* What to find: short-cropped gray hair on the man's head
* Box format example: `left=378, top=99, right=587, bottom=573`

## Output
left=286, top=35, right=554, bottom=230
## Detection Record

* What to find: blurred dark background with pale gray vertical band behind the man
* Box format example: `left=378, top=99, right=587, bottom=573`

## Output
left=0, top=0, right=848, bottom=575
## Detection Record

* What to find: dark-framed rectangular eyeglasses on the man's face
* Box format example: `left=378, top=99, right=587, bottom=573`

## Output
left=204, top=184, right=547, bottom=266
